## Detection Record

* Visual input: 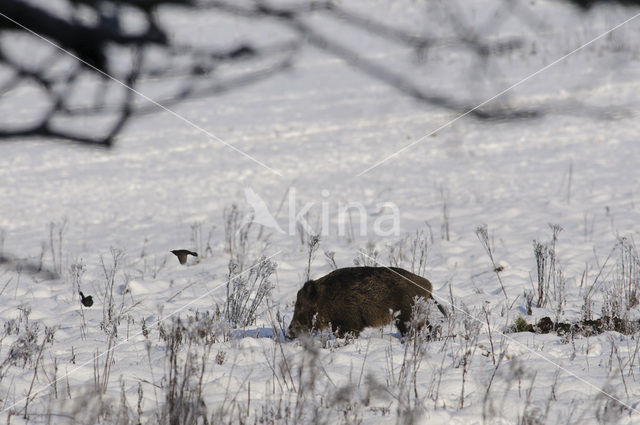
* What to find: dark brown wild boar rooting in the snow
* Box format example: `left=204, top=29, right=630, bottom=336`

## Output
left=287, top=267, right=446, bottom=338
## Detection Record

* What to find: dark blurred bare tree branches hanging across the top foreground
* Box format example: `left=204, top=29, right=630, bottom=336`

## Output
left=0, top=0, right=640, bottom=147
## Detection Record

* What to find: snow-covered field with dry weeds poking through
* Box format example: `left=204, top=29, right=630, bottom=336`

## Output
left=0, top=0, right=640, bottom=424
